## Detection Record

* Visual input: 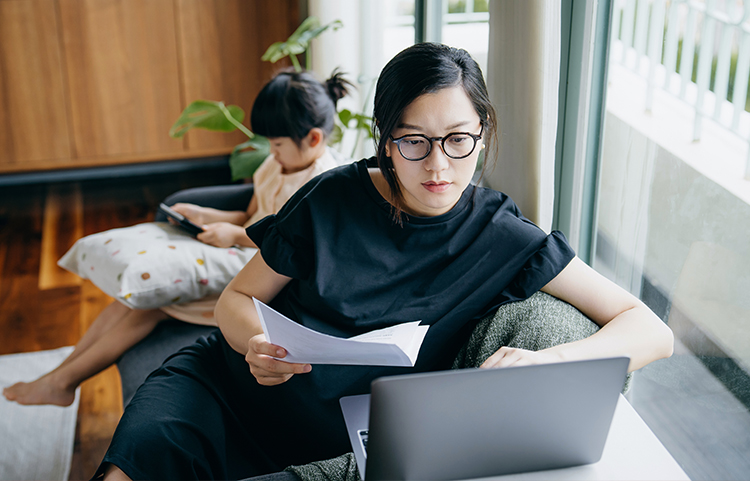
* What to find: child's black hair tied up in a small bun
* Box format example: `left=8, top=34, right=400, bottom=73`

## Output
left=250, top=70, right=352, bottom=145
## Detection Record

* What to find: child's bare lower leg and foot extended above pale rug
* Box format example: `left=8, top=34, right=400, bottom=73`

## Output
left=3, top=309, right=166, bottom=406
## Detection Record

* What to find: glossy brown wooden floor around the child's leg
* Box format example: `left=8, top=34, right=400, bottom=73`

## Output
left=0, top=164, right=229, bottom=480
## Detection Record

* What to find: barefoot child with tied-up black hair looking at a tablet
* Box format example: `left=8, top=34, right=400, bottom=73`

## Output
left=3, top=68, right=351, bottom=406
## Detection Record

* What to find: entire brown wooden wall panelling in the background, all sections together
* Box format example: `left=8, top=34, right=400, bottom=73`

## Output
left=0, top=0, right=300, bottom=175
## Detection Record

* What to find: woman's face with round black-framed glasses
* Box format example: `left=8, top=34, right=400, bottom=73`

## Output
left=386, top=86, right=482, bottom=217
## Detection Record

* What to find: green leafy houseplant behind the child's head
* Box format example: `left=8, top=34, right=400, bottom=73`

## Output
left=169, top=17, right=371, bottom=180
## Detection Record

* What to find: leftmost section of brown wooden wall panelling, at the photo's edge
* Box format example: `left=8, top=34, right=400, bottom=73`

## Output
left=0, top=0, right=70, bottom=169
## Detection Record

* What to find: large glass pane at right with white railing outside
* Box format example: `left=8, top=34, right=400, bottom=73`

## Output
left=594, top=0, right=750, bottom=479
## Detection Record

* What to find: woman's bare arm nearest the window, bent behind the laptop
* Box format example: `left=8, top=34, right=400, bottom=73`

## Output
left=483, top=257, right=674, bottom=371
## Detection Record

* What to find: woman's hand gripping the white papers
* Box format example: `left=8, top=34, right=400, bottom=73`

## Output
left=245, top=334, right=312, bottom=386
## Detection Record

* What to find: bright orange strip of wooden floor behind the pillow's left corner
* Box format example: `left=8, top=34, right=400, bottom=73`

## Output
left=39, top=183, right=83, bottom=290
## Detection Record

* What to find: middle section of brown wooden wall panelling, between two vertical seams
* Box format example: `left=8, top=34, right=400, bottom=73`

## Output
left=59, top=0, right=184, bottom=161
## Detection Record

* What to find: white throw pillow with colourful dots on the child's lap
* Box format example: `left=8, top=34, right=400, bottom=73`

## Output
left=58, top=222, right=258, bottom=309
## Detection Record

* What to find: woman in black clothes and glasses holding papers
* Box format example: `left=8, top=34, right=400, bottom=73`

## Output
left=99, top=44, right=672, bottom=479
